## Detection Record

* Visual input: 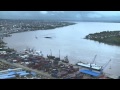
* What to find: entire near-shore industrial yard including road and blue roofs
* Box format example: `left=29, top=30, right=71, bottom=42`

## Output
left=0, top=49, right=116, bottom=79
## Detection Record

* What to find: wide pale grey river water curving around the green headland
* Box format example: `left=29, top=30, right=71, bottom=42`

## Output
left=4, top=22, right=120, bottom=75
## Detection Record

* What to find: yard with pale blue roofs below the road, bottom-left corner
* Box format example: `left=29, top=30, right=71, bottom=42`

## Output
left=0, top=60, right=48, bottom=79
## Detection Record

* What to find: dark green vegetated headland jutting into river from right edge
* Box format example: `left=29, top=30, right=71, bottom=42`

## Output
left=85, top=31, right=120, bottom=46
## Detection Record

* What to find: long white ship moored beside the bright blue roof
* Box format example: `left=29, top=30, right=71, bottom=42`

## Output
left=76, top=62, right=102, bottom=71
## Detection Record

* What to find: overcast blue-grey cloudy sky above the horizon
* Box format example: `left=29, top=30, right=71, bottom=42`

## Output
left=0, top=11, right=120, bottom=21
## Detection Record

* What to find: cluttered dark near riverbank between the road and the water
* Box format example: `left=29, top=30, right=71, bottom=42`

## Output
left=0, top=47, right=118, bottom=79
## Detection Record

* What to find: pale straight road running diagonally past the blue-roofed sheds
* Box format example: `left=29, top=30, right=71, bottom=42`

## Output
left=0, top=59, right=55, bottom=79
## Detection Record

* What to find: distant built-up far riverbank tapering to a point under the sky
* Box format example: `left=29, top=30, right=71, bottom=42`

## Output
left=0, top=19, right=76, bottom=37
